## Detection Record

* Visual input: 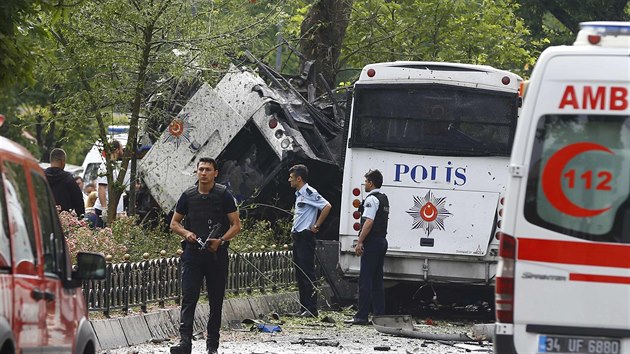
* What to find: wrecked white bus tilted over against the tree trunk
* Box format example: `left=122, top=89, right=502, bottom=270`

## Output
left=138, top=67, right=343, bottom=240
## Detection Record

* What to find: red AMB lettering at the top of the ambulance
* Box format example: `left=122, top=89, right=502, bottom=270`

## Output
left=558, top=85, right=628, bottom=111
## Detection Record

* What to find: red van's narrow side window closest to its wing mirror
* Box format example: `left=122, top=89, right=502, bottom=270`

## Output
left=31, top=171, right=59, bottom=274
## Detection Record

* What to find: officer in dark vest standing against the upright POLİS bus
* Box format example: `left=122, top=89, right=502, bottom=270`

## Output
left=345, top=170, right=389, bottom=325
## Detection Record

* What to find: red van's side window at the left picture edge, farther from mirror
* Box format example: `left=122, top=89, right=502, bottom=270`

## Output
left=4, top=161, right=37, bottom=272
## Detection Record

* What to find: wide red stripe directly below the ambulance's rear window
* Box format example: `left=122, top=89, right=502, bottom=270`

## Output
left=517, top=238, right=630, bottom=268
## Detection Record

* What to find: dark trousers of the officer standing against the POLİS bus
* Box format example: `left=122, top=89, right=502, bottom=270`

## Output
left=354, top=236, right=387, bottom=321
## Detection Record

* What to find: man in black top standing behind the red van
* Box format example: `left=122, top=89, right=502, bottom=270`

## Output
left=44, top=148, right=85, bottom=217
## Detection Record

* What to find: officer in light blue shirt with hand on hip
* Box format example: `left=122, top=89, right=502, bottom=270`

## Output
left=289, top=165, right=332, bottom=317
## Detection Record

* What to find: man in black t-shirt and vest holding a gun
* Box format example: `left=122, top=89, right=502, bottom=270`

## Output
left=171, top=157, right=241, bottom=354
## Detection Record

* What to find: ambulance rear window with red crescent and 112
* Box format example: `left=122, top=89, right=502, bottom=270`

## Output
left=525, top=115, right=630, bottom=243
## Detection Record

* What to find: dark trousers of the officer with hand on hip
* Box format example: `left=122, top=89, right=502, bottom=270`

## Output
left=291, top=230, right=317, bottom=314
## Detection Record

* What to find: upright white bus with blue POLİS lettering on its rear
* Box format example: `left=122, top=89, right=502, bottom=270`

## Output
left=339, top=62, right=522, bottom=294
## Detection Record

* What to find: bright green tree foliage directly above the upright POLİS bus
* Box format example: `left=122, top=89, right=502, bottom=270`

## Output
left=285, top=0, right=544, bottom=84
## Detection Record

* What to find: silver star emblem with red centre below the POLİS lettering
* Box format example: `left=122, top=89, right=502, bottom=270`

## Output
left=407, top=190, right=453, bottom=236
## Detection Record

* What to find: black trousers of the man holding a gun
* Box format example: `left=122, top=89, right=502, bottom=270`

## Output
left=179, top=245, right=229, bottom=348
